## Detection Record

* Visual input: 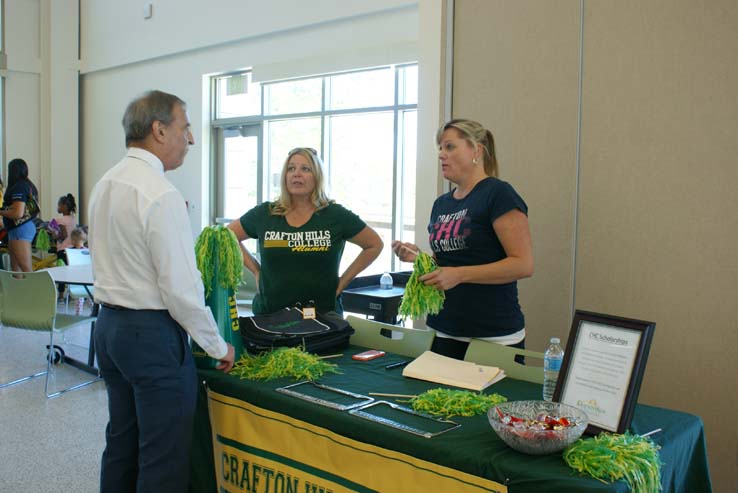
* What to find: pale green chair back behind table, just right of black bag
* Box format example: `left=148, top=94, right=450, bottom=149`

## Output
left=346, top=315, right=436, bottom=358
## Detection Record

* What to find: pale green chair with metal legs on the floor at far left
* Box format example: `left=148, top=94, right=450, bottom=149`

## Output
left=0, top=270, right=102, bottom=397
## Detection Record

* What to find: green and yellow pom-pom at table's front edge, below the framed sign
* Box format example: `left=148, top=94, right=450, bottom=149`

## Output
left=564, top=433, right=661, bottom=493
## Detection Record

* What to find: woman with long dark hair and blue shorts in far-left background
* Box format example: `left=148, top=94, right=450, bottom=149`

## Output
left=0, top=159, right=39, bottom=272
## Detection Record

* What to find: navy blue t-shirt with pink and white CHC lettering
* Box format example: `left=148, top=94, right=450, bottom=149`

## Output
left=427, top=178, right=528, bottom=337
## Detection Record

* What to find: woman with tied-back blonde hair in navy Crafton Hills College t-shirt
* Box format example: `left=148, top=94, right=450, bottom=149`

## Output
left=392, top=119, right=533, bottom=359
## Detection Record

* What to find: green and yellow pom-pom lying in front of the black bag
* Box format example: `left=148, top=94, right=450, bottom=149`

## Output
left=229, top=347, right=339, bottom=381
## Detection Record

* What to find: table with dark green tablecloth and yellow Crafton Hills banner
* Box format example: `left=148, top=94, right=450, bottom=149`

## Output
left=190, top=347, right=711, bottom=493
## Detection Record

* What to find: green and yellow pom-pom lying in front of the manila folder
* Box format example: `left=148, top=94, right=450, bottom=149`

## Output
left=410, top=388, right=507, bottom=418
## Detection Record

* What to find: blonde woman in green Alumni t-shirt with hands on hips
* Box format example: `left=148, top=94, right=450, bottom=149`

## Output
left=228, top=147, right=383, bottom=314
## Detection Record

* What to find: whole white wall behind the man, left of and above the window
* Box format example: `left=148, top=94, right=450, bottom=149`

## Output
left=81, top=0, right=418, bottom=232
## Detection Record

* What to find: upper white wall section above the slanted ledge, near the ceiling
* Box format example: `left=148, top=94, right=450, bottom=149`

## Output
left=81, top=0, right=417, bottom=72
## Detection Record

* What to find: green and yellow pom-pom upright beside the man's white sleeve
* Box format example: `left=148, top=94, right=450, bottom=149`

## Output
left=195, top=226, right=243, bottom=298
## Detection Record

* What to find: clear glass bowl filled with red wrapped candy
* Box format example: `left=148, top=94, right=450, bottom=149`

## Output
left=487, top=401, right=589, bottom=455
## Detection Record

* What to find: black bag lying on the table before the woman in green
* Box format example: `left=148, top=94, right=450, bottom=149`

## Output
left=238, top=307, right=354, bottom=354
